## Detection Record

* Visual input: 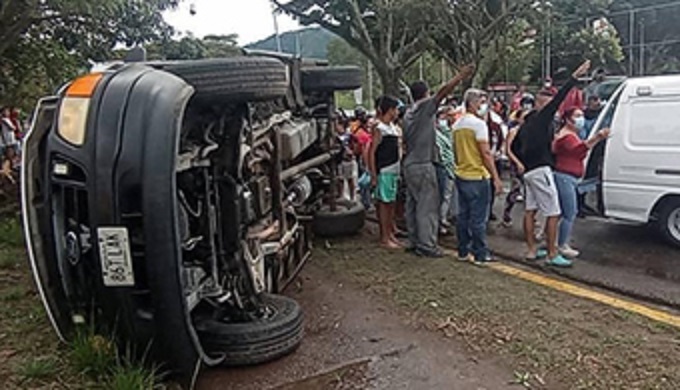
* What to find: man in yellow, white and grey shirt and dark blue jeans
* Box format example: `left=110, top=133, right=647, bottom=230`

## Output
left=453, top=89, right=503, bottom=264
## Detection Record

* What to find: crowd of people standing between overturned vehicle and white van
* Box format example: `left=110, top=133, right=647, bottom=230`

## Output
left=337, top=62, right=609, bottom=267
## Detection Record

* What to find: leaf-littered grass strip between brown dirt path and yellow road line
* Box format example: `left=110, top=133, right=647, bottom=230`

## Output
left=315, top=232, right=680, bottom=389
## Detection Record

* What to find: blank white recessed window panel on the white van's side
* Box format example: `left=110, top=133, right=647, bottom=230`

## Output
left=630, top=99, right=680, bottom=146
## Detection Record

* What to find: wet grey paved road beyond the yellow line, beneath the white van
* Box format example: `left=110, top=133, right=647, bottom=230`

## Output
left=468, top=195, right=680, bottom=307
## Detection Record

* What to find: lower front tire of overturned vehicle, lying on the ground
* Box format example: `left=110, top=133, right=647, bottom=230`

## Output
left=196, top=294, right=304, bottom=366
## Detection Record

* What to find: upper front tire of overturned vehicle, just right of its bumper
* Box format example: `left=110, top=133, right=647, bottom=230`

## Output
left=162, top=57, right=290, bottom=102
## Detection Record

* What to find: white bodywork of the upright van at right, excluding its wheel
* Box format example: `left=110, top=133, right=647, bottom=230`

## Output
left=602, top=83, right=680, bottom=223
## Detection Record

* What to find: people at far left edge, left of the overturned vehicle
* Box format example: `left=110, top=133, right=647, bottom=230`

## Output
left=0, top=107, right=24, bottom=183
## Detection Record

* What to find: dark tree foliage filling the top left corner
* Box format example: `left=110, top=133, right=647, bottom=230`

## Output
left=0, top=0, right=179, bottom=109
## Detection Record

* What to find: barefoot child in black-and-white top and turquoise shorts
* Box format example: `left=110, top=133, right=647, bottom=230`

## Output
left=368, top=96, right=401, bottom=249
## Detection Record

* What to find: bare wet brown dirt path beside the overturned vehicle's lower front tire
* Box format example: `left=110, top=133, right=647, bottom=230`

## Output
left=198, top=249, right=521, bottom=390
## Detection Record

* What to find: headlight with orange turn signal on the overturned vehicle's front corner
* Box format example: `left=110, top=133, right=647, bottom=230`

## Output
left=57, top=73, right=102, bottom=146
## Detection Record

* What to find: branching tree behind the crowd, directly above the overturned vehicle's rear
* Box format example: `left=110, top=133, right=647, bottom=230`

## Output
left=274, top=0, right=430, bottom=95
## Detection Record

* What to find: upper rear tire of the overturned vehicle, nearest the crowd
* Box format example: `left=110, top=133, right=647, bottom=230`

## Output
left=300, top=66, right=363, bottom=92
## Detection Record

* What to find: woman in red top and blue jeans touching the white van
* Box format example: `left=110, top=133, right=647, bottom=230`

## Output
left=552, top=108, right=609, bottom=259
